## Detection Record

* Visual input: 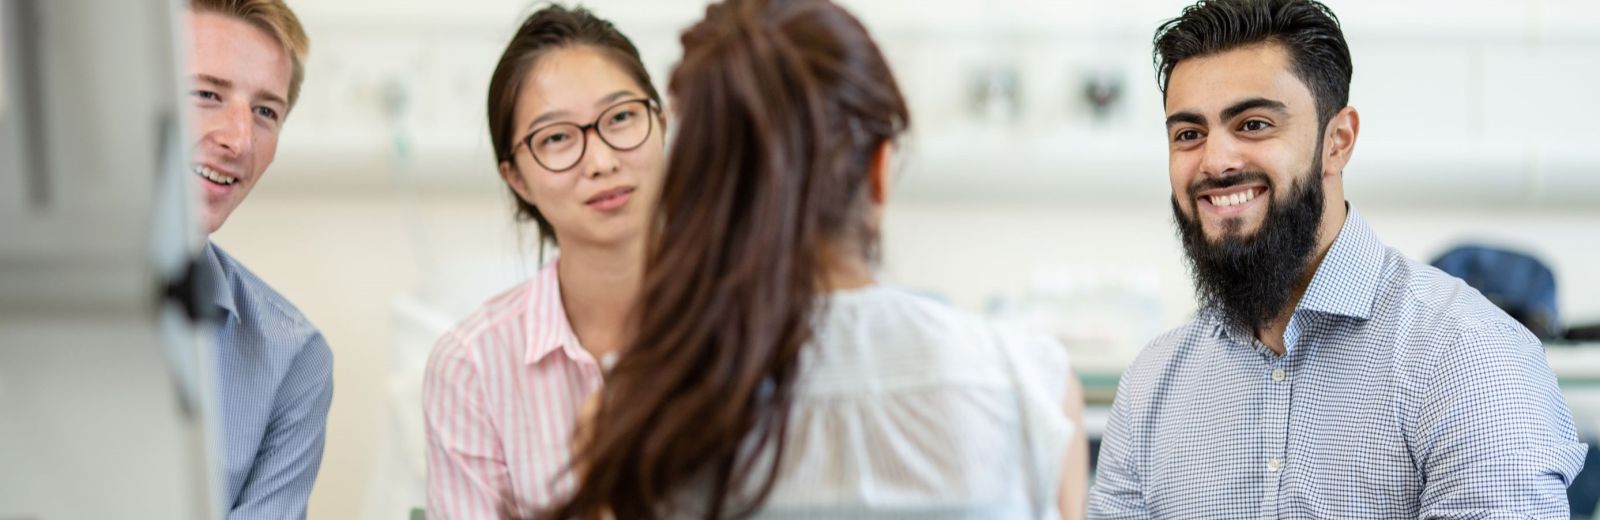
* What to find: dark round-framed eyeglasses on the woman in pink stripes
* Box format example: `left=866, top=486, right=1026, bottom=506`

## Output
left=512, top=99, right=661, bottom=173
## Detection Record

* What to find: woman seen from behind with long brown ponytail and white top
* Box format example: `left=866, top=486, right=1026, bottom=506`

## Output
left=544, top=0, right=1088, bottom=520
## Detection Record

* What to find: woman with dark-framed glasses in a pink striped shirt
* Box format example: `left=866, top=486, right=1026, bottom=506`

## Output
left=422, top=5, right=666, bottom=520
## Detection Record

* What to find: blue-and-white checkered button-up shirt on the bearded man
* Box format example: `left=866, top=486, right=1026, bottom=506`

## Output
left=1090, top=210, right=1587, bottom=518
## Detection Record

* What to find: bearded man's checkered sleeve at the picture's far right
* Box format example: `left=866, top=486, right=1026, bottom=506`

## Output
left=1408, top=323, right=1587, bottom=518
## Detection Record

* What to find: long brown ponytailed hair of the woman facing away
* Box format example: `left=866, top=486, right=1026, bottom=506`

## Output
left=547, top=0, right=910, bottom=518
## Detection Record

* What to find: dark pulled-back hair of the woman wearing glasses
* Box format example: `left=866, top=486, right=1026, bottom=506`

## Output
left=488, top=3, right=661, bottom=245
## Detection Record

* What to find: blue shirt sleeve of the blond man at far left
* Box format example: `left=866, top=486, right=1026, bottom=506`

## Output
left=227, top=333, right=333, bottom=520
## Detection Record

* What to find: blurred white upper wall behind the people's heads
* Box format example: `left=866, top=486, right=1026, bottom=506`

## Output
left=272, top=0, right=1600, bottom=208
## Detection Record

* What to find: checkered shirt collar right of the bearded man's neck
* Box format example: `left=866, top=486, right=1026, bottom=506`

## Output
left=1294, top=208, right=1384, bottom=320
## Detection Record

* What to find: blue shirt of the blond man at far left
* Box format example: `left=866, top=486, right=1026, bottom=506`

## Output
left=202, top=243, right=333, bottom=520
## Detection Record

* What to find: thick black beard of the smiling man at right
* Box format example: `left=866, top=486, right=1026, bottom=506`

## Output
left=1173, top=158, right=1323, bottom=333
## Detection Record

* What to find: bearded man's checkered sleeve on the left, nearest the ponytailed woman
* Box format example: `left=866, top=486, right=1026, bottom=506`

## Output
left=1088, top=366, right=1150, bottom=520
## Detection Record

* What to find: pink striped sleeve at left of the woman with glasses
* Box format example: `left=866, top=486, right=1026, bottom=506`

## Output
left=422, top=334, right=510, bottom=520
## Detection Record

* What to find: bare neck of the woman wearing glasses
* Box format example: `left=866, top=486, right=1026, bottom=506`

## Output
left=555, top=240, right=645, bottom=360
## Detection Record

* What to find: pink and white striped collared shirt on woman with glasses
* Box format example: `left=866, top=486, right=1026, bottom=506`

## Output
left=422, top=261, right=600, bottom=520
